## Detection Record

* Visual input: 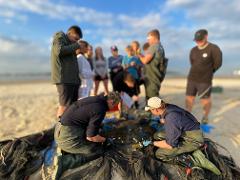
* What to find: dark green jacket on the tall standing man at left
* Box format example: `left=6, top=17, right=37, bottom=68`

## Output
left=51, top=32, right=80, bottom=84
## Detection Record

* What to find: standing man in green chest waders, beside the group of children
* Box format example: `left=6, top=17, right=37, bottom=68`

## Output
left=139, top=29, right=167, bottom=99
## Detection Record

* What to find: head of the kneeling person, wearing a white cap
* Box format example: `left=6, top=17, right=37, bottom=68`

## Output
left=145, top=97, right=166, bottom=116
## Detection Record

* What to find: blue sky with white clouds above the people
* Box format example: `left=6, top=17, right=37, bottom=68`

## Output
left=0, top=0, right=240, bottom=74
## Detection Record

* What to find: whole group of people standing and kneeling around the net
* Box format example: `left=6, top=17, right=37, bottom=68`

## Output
left=51, top=26, right=222, bottom=179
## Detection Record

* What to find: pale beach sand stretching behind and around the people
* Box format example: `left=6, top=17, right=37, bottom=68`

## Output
left=0, top=78, right=240, bottom=165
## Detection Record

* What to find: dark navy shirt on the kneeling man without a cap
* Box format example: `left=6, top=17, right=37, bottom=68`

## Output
left=61, top=95, right=109, bottom=137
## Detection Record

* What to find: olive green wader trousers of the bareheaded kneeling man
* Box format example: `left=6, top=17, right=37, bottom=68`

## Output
left=54, top=122, right=103, bottom=156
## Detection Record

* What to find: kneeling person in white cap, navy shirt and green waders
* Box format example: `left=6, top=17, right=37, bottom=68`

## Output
left=145, top=97, right=220, bottom=174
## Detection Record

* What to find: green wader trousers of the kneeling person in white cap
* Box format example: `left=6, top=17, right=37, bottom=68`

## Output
left=154, top=130, right=204, bottom=161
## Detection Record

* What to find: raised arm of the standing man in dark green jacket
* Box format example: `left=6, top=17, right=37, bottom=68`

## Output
left=53, top=35, right=80, bottom=56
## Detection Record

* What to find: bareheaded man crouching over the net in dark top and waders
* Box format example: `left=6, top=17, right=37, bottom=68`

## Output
left=53, top=92, right=121, bottom=179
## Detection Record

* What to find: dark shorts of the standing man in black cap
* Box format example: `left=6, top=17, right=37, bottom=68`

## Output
left=186, top=81, right=212, bottom=99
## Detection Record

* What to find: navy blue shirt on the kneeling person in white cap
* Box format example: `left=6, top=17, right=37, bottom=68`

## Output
left=161, top=104, right=200, bottom=147
